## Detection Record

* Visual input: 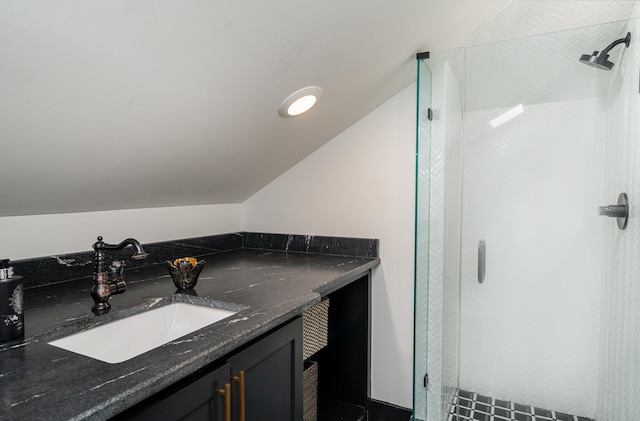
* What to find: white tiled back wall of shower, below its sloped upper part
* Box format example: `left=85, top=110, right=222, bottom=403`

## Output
left=460, top=99, right=605, bottom=417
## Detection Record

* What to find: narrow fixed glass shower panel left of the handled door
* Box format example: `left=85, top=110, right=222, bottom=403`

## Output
left=414, top=50, right=463, bottom=420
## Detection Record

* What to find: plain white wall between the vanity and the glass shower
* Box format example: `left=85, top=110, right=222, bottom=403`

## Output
left=242, top=84, right=416, bottom=408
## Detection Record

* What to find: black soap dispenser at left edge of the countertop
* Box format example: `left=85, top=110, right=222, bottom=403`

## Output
left=0, top=259, right=24, bottom=342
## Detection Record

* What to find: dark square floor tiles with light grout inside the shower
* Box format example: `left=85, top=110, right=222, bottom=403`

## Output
left=449, top=390, right=593, bottom=421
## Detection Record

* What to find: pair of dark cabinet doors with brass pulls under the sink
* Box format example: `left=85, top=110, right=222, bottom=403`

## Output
left=115, top=317, right=302, bottom=421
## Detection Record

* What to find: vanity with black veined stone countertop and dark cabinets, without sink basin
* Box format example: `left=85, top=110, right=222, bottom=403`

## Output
left=0, top=235, right=379, bottom=420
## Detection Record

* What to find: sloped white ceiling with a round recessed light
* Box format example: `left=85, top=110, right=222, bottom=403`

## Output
left=0, top=0, right=507, bottom=216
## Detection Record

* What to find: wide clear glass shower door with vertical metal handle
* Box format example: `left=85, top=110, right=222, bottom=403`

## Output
left=459, top=22, right=626, bottom=419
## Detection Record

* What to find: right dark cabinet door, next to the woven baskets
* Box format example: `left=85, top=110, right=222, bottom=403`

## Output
left=228, top=317, right=302, bottom=421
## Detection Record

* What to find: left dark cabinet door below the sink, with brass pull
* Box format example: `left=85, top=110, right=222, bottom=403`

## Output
left=117, top=364, right=231, bottom=421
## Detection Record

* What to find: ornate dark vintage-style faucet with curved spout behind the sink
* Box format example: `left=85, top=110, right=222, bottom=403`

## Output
left=91, top=237, right=149, bottom=314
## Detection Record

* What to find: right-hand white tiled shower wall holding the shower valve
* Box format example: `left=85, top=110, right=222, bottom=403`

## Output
left=596, top=12, right=640, bottom=421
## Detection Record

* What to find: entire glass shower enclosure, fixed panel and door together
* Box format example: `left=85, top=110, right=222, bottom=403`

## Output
left=413, top=19, right=640, bottom=421
